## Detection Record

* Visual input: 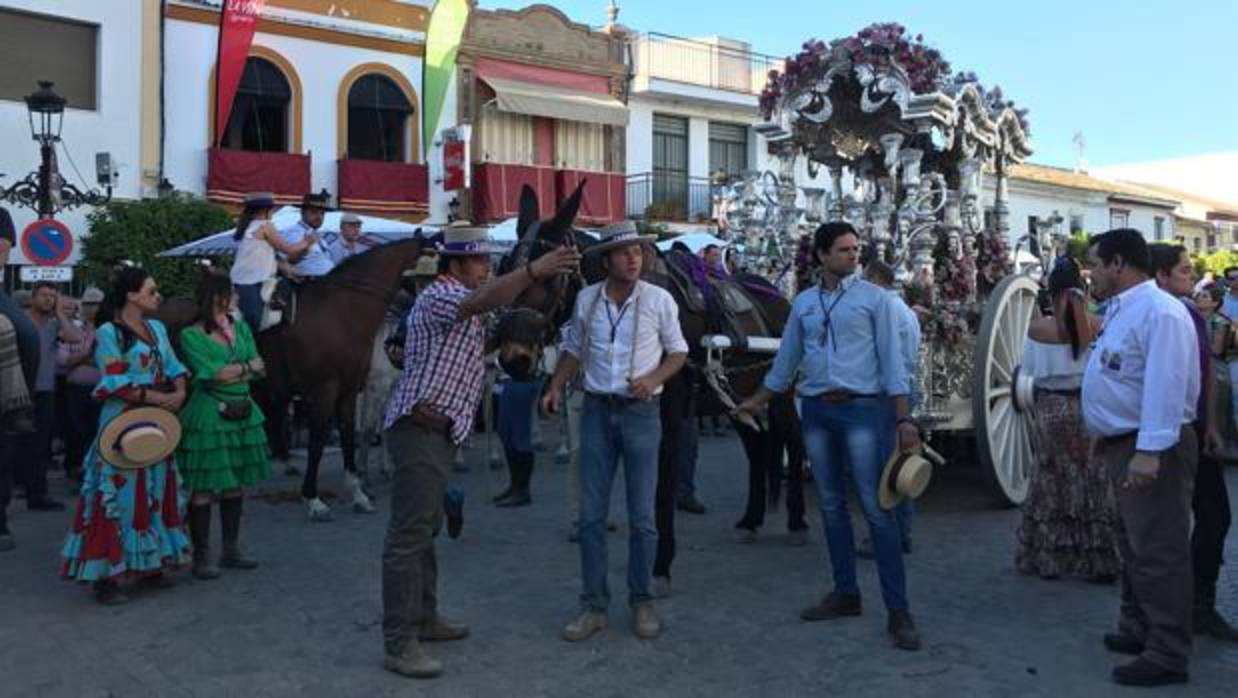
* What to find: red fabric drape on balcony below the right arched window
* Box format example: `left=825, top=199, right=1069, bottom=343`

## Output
left=339, top=160, right=430, bottom=213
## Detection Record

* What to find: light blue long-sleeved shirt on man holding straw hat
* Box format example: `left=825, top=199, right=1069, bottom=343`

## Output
left=765, top=275, right=907, bottom=397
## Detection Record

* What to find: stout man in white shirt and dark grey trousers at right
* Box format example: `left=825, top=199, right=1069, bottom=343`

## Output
left=1083, top=229, right=1200, bottom=686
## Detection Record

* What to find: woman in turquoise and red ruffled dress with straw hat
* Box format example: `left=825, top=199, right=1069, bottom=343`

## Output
left=62, top=266, right=189, bottom=604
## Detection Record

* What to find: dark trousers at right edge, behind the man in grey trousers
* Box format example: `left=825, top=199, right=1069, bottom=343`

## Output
left=1191, top=432, right=1231, bottom=598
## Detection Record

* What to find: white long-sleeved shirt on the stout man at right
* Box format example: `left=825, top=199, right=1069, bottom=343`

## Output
left=1083, top=281, right=1200, bottom=452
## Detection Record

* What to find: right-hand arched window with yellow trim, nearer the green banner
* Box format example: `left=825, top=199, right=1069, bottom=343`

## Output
left=348, top=73, right=412, bottom=162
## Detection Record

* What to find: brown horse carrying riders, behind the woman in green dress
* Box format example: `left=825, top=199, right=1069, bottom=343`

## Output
left=160, top=238, right=423, bottom=521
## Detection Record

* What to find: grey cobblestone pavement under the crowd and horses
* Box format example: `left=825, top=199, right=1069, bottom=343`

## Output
left=0, top=425, right=1238, bottom=698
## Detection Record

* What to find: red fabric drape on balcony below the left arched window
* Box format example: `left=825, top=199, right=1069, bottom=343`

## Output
left=207, top=149, right=310, bottom=204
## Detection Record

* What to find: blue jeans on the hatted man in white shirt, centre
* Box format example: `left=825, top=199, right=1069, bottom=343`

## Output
left=581, top=395, right=662, bottom=613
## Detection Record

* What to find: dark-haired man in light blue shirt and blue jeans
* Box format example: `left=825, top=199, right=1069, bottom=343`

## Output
left=739, top=223, right=920, bottom=650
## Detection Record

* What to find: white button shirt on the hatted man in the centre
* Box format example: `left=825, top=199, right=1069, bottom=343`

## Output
left=561, top=281, right=688, bottom=396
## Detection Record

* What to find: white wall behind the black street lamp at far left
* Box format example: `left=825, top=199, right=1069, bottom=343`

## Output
left=0, top=0, right=142, bottom=265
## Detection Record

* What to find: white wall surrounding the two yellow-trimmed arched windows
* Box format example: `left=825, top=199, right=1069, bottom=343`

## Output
left=166, top=20, right=428, bottom=210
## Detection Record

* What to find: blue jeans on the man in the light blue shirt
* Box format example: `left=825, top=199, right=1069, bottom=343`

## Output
left=803, top=397, right=907, bottom=610
